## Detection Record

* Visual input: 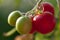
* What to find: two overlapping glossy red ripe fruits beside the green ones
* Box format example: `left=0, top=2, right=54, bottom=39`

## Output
left=32, top=2, right=56, bottom=34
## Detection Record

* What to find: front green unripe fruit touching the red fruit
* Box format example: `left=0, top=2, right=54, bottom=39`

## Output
left=16, top=16, right=32, bottom=34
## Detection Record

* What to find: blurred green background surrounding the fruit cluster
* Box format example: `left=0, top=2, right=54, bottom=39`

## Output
left=0, top=0, right=60, bottom=40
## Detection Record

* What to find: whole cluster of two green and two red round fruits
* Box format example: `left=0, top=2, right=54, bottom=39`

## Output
left=8, top=2, right=56, bottom=34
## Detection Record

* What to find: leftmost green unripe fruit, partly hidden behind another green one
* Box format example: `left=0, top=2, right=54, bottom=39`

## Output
left=8, top=11, right=22, bottom=26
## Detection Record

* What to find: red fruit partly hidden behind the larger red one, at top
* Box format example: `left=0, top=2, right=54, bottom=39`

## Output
left=37, top=2, right=54, bottom=15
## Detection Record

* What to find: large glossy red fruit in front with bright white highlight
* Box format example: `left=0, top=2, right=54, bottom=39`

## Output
left=33, top=12, right=56, bottom=34
